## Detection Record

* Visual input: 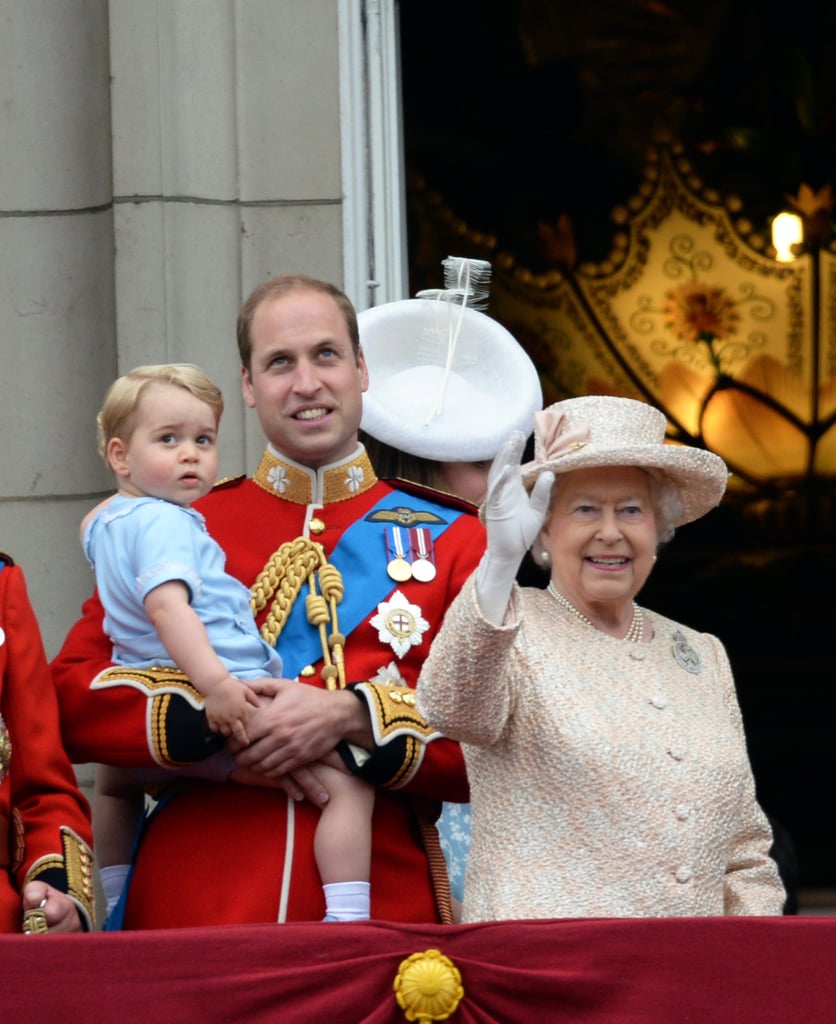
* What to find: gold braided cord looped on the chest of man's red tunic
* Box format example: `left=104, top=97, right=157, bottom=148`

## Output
left=250, top=537, right=345, bottom=690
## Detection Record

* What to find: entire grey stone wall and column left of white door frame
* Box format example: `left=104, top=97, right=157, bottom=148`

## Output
left=0, top=0, right=352, bottom=655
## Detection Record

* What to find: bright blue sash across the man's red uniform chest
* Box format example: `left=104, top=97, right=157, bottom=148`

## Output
left=276, top=490, right=463, bottom=679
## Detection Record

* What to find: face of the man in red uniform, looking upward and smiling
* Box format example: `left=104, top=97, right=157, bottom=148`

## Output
left=242, top=290, right=369, bottom=469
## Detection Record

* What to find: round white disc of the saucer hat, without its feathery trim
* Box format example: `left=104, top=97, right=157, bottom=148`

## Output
left=358, top=291, right=543, bottom=462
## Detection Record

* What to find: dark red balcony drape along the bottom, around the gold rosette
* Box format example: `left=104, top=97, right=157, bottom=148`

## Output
left=0, top=916, right=836, bottom=1024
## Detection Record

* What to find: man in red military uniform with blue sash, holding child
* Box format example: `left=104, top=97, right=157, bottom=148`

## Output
left=53, top=275, right=485, bottom=928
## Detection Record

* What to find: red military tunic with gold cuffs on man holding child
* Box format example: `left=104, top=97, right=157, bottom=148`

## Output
left=53, top=447, right=485, bottom=928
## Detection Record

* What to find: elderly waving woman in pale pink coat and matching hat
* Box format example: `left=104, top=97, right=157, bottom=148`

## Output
left=418, top=396, right=785, bottom=922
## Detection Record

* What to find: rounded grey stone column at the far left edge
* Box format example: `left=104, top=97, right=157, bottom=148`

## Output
left=0, top=0, right=116, bottom=653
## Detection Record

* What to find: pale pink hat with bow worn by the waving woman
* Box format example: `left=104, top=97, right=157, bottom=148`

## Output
left=523, top=395, right=728, bottom=526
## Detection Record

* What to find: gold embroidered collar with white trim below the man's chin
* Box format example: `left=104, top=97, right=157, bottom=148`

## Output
left=253, top=444, right=377, bottom=505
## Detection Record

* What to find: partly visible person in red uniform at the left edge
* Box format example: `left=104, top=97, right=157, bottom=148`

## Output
left=0, top=554, right=93, bottom=934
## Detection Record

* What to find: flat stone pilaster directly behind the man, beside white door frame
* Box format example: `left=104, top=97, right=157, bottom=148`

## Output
left=110, top=0, right=342, bottom=475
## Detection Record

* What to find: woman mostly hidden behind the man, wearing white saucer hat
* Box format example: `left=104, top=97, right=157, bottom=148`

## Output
left=358, top=256, right=545, bottom=914
